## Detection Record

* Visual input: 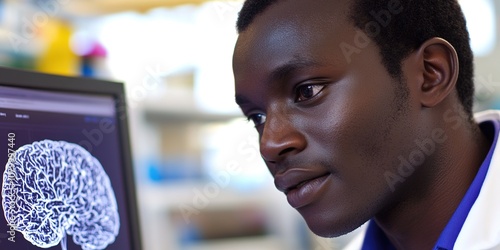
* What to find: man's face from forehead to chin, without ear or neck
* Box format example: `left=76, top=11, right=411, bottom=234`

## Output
left=233, top=0, right=419, bottom=236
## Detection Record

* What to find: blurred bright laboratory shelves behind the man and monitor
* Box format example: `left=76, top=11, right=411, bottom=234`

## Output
left=0, top=0, right=500, bottom=250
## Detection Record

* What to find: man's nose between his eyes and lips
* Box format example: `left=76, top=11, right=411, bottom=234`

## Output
left=260, top=110, right=307, bottom=164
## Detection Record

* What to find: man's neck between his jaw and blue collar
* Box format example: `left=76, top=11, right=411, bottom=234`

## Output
left=375, top=119, right=491, bottom=250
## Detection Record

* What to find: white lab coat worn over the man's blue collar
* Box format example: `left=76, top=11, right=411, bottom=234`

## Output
left=344, top=110, right=500, bottom=250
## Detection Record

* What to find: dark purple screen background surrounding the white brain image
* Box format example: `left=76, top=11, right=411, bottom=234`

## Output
left=0, top=103, right=135, bottom=250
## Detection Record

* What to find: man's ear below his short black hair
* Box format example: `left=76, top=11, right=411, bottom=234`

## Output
left=414, top=37, right=459, bottom=108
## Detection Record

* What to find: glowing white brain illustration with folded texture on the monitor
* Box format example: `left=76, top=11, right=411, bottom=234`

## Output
left=2, top=140, right=120, bottom=250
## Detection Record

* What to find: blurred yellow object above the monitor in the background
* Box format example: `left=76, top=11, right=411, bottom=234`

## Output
left=35, top=19, right=80, bottom=76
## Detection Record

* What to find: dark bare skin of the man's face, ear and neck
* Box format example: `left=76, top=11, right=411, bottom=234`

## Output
left=233, top=0, right=490, bottom=250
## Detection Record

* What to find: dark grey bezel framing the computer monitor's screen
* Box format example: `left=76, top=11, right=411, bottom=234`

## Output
left=0, top=67, right=142, bottom=249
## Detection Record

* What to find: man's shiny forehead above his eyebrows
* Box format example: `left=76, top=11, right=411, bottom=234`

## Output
left=233, top=0, right=352, bottom=66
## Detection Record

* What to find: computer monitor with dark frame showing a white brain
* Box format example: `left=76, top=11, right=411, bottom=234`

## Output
left=0, top=68, right=141, bottom=250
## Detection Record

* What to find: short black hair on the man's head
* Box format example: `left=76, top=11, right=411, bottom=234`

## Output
left=236, top=0, right=474, bottom=118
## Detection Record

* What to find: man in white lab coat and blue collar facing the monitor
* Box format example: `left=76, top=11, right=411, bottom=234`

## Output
left=233, top=0, right=500, bottom=250
